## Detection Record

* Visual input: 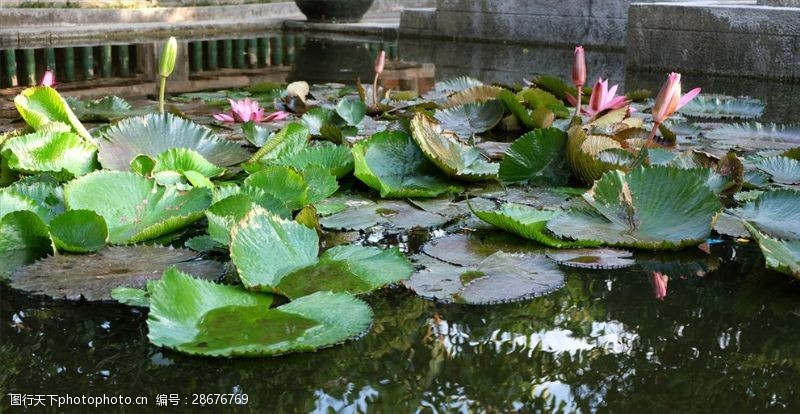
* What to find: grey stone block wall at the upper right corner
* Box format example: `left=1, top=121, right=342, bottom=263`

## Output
left=626, top=2, right=800, bottom=80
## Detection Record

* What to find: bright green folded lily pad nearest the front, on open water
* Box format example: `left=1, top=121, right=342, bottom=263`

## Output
left=147, top=270, right=372, bottom=357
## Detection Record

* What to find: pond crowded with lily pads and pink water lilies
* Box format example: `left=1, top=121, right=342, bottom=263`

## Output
left=0, top=37, right=800, bottom=413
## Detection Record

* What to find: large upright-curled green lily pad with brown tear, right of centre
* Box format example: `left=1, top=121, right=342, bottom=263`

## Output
left=547, top=166, right=722, bottom=250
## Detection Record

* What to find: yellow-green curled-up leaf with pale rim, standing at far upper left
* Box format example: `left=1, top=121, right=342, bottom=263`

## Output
left=14, top=86, right=93, bottom=141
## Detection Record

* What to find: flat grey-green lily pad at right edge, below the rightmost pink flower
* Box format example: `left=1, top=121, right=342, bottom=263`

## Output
left=704, top=122, right=800, bottom=150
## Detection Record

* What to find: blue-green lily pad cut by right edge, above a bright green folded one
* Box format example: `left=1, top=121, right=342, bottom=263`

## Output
left=728, top=189, right=800, bottom=239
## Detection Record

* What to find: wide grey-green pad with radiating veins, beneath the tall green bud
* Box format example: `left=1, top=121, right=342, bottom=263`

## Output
left=98, top=114, right=250, bottom=171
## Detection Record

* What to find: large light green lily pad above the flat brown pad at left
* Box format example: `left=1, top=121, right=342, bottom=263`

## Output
left=64, top=171, right=211, bottom=244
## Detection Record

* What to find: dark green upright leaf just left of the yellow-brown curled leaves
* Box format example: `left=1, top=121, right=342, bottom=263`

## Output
left=499, top=128, right=570, bottom=185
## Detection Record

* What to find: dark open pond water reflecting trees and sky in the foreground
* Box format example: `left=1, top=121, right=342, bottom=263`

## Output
left=0, top=34, right=800, bottom=413
